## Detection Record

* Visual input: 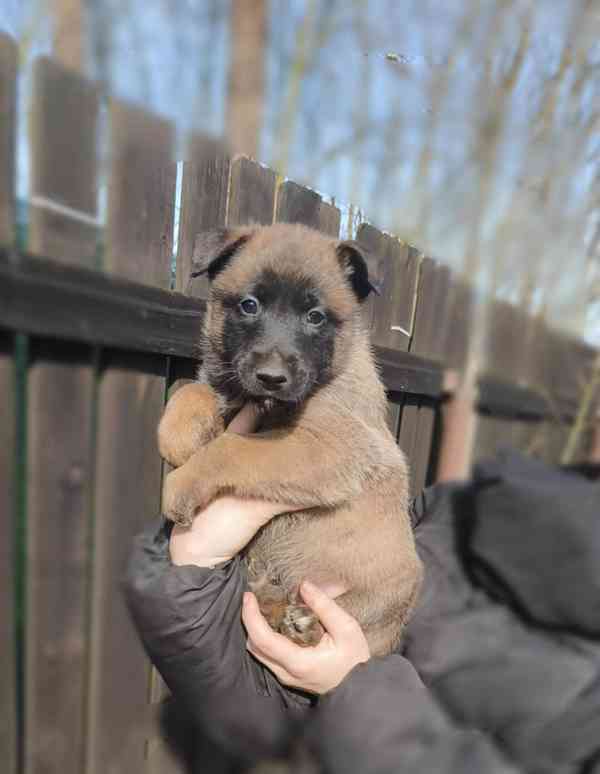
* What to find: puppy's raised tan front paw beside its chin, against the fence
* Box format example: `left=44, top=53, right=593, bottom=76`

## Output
left=158, top=382, right=224, bottom=468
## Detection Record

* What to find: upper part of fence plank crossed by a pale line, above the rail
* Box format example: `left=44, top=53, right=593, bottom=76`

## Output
left=29, top=58, right=98, bottom=266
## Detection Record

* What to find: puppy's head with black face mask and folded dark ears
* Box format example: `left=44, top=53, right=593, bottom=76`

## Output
left=194, top=224, right=373, bottom=405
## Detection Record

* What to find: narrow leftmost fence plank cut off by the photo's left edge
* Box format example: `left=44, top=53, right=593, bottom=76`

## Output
left=0, top=33, right=17, bottom=774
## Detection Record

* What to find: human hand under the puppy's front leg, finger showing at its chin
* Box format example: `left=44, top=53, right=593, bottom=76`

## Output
left=169, top=404, right=294, bottom=567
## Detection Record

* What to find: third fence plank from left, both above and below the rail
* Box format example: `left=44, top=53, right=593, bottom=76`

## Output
left=85, top=101, right=176, bottom=774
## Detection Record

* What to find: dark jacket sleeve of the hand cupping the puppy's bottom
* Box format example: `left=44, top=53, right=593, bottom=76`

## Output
left=305, top=654, right=518, bottom=774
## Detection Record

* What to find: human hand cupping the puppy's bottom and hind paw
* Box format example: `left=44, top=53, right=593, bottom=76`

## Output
left=242, top=581, right=371, bottom=694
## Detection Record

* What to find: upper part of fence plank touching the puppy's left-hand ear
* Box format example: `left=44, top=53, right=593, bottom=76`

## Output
left=175, top=135, right=230, bottom=298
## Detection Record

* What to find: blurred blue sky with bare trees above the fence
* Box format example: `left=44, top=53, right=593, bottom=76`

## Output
left=0, top=0, right=600, bottom=341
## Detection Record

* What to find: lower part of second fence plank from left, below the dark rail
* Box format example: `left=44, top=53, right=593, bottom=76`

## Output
left=25, top=342, right=93, bottom=774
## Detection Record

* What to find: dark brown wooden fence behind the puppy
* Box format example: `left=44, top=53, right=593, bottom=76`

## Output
left=0, top=36, right=591, bottom=774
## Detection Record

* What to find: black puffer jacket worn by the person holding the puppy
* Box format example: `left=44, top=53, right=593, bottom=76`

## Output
left=125, top=455, right=600, bottom=774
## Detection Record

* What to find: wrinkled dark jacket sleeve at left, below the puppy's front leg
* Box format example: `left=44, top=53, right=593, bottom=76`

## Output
left=124, top=523, right=311, bottom=760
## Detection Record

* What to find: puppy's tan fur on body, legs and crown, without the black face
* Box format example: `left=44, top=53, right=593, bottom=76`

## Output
left=159, top=225, right=422, bottom=655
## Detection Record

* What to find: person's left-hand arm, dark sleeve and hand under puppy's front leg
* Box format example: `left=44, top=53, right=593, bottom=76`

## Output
left=124, top=406, right=310, bottom=760
